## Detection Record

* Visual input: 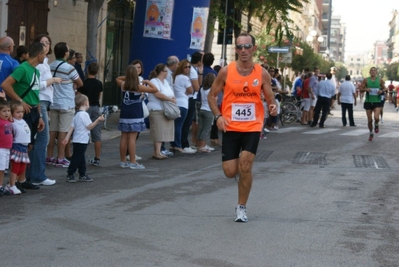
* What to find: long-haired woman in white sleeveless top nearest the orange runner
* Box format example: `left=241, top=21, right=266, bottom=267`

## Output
left=197, top=73, right=216, bottom=152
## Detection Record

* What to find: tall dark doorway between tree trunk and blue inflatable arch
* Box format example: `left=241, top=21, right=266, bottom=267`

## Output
left=103, top=0, right=134, bottom=105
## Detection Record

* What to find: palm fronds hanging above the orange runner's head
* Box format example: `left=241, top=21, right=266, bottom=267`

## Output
left=205, top=0, right=308, bottom=51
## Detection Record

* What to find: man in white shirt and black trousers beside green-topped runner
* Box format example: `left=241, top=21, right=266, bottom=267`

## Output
left=337, top=75, right=356, bottom=126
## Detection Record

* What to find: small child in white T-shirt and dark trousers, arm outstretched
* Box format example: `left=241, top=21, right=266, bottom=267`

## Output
left=62, top=94, right=104, bottom=183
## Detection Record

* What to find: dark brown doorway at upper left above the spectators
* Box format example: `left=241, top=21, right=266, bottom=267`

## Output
left=6, top=0, right=49, bottom=54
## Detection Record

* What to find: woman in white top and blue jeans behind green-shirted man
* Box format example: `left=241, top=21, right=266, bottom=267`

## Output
left=26, top=34, right=61, bottom=185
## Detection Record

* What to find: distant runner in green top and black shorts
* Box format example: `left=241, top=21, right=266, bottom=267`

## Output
left=360, top=67, right=387, bottom=141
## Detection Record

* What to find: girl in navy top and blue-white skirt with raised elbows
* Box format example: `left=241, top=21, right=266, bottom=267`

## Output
left=116, top=65, right=157, bottom=169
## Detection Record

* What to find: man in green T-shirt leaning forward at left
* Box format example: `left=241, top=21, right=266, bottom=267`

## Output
left=1, top=43, right=46, bottom=189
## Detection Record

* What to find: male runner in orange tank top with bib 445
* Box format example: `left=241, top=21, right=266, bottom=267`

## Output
left=208, top=33, right=277, bottom=222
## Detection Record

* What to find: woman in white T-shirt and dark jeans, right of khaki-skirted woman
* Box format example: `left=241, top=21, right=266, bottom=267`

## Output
left=170, top=59, right=195, bottom=153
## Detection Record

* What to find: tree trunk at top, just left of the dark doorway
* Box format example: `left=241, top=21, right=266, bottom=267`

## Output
left=86, top=0, right=104, bottom=60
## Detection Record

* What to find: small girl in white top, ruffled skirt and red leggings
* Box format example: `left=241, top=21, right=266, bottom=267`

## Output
left=6, top=100, right=31, bottom=195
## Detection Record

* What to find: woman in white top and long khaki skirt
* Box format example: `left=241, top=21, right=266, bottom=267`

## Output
left=147, top=64, right=176, bottom=159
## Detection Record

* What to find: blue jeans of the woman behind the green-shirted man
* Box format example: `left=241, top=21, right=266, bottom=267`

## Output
left=26, top=101, right=51, bottom=183
